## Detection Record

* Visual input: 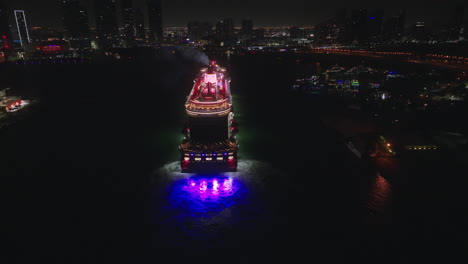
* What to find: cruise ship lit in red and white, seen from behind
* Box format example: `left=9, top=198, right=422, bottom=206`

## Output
left=179, top=61, right=239, bottom=172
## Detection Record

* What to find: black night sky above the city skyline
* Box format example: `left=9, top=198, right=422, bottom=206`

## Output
left=4, top=0, right=467, bottom=26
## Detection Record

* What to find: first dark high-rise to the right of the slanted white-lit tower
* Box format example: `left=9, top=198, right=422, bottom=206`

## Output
left=62, top=0, right=89, bottom=39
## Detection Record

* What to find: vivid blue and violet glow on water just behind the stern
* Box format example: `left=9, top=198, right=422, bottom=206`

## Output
left=161, top=175, right=250, bottom=240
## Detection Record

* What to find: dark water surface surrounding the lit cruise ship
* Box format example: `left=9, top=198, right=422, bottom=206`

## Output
left=0, top=52, right=468, bottom=263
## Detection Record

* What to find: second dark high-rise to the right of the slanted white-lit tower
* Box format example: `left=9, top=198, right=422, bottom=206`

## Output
left=94, top=0, right=118, bottom=40
